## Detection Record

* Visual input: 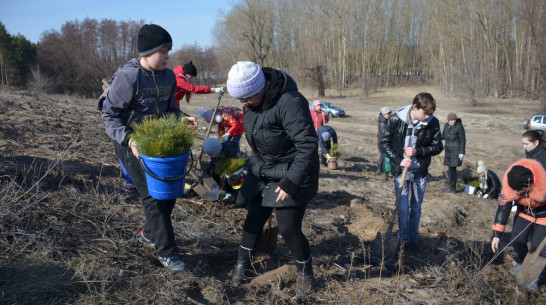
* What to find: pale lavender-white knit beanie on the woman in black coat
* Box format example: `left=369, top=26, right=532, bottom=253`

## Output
left=227, top=61, right=265, bottom=98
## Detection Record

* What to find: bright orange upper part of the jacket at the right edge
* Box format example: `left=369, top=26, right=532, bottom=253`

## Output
left=501, top=159, right=546, bottom=207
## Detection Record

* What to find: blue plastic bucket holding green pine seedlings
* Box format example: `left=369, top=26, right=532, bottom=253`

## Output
left=140, top=151, right=193, bottom=200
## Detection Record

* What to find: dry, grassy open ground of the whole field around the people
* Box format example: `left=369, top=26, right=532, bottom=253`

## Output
left=0, top=87, right=546, bottom=304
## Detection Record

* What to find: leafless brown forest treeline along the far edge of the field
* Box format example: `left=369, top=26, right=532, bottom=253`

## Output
left=0, top=0, right=546, bottom=103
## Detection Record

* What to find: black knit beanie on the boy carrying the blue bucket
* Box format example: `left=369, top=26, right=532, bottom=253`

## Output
left=137, top=24, right=173, bottom=56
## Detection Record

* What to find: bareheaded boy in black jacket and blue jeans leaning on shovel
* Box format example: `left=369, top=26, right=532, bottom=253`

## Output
left=380, top=92, right=444, bottom=255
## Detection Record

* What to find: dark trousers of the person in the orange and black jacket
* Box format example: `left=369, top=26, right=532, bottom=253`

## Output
left=510, top=217, right=546, bottom=264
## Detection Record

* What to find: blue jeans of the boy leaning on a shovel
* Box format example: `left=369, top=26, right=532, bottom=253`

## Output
left=394, top=170, right=427, bottom=244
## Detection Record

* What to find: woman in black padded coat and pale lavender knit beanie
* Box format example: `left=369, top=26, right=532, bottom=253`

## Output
left=227, top=61, right=320, bottom=295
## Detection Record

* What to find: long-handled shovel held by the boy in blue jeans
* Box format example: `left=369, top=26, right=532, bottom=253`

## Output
left=372, top=167, right=408, bottom=262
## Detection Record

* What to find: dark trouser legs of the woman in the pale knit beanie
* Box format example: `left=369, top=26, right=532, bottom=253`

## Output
left=241, top=195, right=311, bottom=261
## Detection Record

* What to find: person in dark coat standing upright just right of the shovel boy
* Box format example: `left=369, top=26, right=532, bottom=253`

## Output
left=442, top=112, right=466, bottom=193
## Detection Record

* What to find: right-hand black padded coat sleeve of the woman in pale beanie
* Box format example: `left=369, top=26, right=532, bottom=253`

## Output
left=278, top=96, right=318, bottom=196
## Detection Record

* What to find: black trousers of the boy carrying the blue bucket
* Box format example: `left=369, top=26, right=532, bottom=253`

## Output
left=114, top=141, right=176, bottom=257
